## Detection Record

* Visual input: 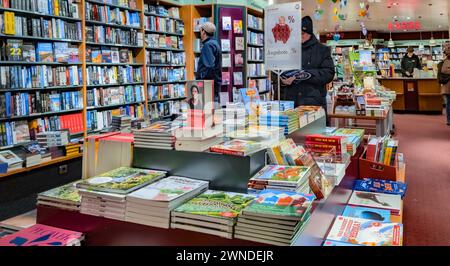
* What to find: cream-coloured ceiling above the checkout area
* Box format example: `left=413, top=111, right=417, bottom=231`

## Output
left=274, top=0, right=450, bottom=33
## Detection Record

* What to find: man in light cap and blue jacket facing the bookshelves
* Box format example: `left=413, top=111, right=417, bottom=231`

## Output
left=195, top=22, right=222, bottom=102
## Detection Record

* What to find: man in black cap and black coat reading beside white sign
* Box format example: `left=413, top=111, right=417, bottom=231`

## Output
left=281, top=16, right=335, bottom=116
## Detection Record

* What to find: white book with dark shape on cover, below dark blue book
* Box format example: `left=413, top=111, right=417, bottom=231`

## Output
left=348, top=191, right=402, bottom=213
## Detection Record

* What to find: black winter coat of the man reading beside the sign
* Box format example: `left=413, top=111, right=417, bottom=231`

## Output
left=281, top=35, right=335, bottom=110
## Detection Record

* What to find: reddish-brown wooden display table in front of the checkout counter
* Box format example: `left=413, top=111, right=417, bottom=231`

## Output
left=328, top=108, right=393, bottom=137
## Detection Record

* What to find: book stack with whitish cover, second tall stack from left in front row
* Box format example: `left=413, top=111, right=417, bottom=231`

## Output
left=126, top=176, right=208, bottom=229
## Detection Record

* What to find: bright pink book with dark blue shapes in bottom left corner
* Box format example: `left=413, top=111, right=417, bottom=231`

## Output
left=0, top=224, right=84, bottom=246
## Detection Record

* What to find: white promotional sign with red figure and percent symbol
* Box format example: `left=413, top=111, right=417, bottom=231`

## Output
left=264, top=2, right=302, bottom=70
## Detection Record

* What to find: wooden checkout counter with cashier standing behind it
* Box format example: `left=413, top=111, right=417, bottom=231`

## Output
left=378, top=77, right=443, bottom=114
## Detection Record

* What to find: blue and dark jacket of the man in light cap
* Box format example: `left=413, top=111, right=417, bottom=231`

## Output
left=195, top=38, right=222, bottom=95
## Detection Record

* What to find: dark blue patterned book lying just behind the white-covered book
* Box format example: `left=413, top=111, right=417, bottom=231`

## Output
left=353, top=178, right=408, bottom=198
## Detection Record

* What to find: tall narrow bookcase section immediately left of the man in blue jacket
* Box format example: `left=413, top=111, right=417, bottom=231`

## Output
left=144, top=0, right=188, bottom=121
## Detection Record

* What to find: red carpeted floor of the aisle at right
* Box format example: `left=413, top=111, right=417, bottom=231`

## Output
left=394, top=112, right=450, bottom=246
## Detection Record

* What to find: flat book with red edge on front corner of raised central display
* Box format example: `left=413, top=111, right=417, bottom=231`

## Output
left=210, top=139, right=264, bottom=156
